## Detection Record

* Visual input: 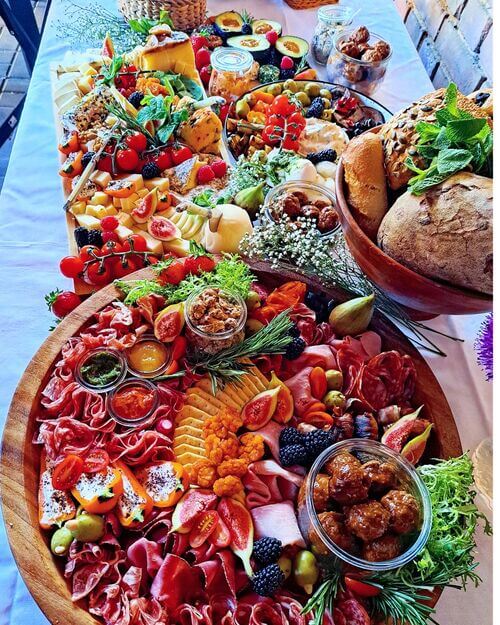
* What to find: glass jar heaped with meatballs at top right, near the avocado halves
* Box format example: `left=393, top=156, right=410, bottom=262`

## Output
left=326, top=26, right=392, bottom=95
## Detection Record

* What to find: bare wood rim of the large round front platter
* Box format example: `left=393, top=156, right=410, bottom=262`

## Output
left=0, top=263, right=462, bottom=625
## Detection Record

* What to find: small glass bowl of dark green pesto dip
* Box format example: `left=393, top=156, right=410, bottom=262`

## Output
left=75, top=347, right=127, bottom=393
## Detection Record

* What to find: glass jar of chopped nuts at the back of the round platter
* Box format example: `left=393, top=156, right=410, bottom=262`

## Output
left=185, top=286, right=247, bottom=354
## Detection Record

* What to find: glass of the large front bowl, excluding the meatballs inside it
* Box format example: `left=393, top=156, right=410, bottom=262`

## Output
left=298, top=439, right=432, bottom=573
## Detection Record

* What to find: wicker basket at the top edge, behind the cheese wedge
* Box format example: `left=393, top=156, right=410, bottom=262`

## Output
left=118, top=0, right=207, bottom=30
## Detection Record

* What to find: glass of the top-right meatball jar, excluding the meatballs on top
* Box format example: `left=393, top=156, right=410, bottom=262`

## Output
left=326, top=31, right=392, bottom=95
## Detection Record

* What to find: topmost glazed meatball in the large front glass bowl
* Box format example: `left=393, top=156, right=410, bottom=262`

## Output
left=326, top=453, right=370, bottom=505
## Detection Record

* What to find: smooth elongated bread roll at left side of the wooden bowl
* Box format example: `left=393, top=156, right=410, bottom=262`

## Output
left=342, top=132, right=387, bottom=239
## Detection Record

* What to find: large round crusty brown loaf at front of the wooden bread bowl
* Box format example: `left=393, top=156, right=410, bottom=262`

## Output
left=378, top=172, right=493, bottom=294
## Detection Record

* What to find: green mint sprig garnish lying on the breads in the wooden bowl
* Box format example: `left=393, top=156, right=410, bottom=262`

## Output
left=405, top=83, right=493, bottom=195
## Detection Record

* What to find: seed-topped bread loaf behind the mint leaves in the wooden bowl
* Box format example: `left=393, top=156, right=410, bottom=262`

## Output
left=380, top=89, right=490, bottom=191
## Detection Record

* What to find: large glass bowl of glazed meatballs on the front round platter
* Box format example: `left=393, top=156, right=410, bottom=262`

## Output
left=298, top=439, right=432, bottom=572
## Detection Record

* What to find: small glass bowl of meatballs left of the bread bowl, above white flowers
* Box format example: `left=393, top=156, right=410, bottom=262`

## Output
left=264, top=182, right=340, bottom=238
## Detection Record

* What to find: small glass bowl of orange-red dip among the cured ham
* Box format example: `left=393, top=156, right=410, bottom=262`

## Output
left=106, top=378, right=159, bottom=427
